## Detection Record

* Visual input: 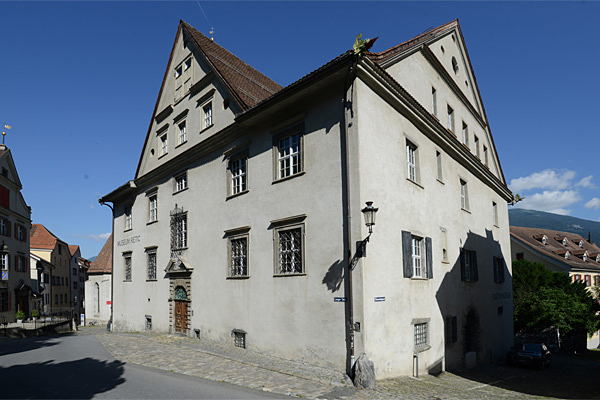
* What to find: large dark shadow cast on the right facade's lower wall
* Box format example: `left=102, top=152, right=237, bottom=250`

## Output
left=430, top=230, right=512, bottom=373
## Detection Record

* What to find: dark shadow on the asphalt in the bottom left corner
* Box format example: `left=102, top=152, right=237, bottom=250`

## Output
left=0, top=358, right=125, bottom=399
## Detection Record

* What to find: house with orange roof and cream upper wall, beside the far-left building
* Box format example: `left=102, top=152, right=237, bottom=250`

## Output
left=30, top=224, right=72, bottom=314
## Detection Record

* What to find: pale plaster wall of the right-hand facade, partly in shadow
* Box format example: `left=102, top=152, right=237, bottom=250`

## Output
left=356, top=81, right=512, bottom=378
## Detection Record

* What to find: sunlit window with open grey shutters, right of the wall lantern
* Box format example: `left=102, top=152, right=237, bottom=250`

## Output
left=402, top=231, right=433, bottom=279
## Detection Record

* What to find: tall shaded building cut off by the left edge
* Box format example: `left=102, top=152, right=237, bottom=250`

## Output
left=0, top=144, right=32, bottom=323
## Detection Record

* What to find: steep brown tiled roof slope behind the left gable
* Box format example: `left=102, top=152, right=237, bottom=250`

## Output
left=181, top=21, right=283, bottom=110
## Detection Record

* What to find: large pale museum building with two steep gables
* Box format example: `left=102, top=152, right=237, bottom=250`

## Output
left=101, top=21, right=513, bottom=378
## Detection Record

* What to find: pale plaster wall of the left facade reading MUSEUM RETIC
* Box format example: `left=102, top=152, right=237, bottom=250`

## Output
left=114, top=93, right=346, bottom=370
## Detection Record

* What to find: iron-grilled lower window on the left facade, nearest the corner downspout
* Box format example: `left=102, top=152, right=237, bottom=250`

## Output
left=274, top=219, right=304, bottom=275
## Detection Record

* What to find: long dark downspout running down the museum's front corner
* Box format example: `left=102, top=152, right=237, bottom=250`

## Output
left=341, top=54, right=358, bottom=378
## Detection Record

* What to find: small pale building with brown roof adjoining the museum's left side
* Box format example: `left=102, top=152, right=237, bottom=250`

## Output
left=85, top=235, right=113, bottom=323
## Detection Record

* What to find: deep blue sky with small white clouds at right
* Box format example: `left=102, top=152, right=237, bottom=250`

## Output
left=0, top=1, right=600, bottom=258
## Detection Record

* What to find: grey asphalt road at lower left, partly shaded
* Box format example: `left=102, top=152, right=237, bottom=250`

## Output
left=0, top=335, right=287, bottom=399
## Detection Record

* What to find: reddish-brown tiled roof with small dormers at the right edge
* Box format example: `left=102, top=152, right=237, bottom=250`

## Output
left=510, top=226, right=600, bottom=270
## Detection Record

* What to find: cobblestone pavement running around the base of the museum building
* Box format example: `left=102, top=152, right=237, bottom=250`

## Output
left=78, top=327, right=600, bottom=400
